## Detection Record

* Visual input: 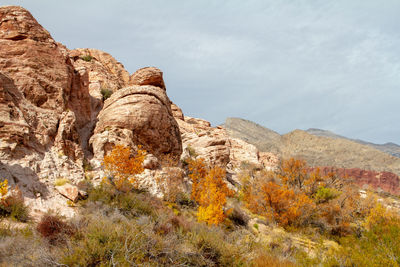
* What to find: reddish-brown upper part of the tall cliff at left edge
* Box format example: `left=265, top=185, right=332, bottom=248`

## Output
left=0, top=6, right=74, bottom=112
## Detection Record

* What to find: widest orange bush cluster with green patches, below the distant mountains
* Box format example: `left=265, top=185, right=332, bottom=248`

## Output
left=242, top=159, right=368, bottom=232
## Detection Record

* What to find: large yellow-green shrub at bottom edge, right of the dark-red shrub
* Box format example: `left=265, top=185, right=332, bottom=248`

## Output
left=60, top=215, right=200, bottom=266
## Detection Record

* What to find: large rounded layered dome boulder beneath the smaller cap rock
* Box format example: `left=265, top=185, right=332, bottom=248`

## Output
left=90, top=78, right=182, bottom=159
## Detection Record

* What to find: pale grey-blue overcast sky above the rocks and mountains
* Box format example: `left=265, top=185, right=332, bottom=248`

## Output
left=1, top=0, right=400, bottom=143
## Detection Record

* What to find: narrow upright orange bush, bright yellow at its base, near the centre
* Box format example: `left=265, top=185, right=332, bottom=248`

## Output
left=188, top=159, right=232, bottom=225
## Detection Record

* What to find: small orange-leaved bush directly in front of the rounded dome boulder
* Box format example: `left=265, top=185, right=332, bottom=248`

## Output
left=103, top=145, right=146, bottom=191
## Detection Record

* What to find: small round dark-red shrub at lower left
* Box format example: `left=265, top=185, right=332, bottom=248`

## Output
left=36, top=214, right=75, bottom=245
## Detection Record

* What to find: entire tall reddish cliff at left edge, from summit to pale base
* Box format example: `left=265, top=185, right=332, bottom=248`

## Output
left=0, top=6, right=91, bottom=218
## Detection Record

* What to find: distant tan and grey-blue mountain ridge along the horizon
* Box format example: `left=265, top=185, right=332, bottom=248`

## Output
left=223, top=118, right=400, bottom=175
